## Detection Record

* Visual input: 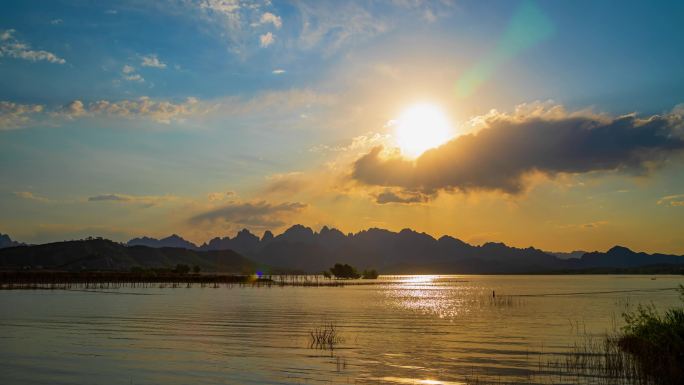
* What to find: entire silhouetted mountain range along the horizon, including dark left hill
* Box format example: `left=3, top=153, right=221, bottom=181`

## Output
left=0, top=225, right=684, bottom=274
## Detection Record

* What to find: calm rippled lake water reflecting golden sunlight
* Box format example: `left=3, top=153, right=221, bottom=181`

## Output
left=0, top=275, right=684, bottom=385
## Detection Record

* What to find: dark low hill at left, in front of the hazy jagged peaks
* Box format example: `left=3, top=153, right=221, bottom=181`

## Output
left=0, top=239, right=268, bottom=274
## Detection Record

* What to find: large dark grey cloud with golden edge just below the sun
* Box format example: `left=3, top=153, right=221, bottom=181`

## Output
left=352, top=104, right=684, bottom=194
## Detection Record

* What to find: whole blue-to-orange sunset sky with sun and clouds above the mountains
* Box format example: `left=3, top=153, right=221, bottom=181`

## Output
left=0, top=0, right=684, bottom=254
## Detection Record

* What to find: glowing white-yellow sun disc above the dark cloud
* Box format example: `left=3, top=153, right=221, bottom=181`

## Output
left=394, top=103, right=451, bottom=158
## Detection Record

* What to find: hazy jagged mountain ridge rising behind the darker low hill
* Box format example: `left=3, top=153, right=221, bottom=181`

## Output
left=129, top=225, right=684, bottom=274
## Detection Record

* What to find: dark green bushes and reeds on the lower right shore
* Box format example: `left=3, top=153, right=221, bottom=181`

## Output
left=538, top=285, right=684, bottom=385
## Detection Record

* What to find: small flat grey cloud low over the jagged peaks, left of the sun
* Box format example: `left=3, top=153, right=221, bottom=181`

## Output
left=188, top=201, right=307, bottom=228
